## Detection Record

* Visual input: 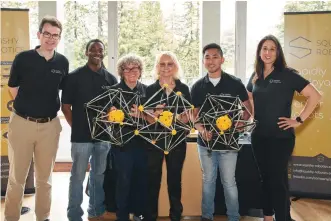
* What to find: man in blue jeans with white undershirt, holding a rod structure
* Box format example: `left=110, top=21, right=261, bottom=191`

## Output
left=191, top=43, right=251, bottom=221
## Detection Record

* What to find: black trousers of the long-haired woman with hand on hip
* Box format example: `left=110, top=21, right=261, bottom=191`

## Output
left=252, top=134, right=295, bottom=221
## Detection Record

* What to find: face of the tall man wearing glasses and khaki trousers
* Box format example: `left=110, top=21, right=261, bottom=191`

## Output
left=37, top=23, right=61, bottom=51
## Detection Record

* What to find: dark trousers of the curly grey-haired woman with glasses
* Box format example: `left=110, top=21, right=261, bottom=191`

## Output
left=112, top=146, right=147, bottom=221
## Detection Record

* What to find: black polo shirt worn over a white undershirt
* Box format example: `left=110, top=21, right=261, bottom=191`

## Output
left=191, top=71, right=248, bottom=149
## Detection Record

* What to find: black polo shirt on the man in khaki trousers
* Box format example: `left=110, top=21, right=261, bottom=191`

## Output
left=8, top=46, right=69, bottom=118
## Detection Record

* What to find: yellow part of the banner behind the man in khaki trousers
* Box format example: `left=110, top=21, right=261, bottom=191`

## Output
left=0, top=8, right=30, bottom=156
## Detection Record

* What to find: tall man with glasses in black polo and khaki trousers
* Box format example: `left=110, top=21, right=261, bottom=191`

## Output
left=5, top=16, right=69, bottom=221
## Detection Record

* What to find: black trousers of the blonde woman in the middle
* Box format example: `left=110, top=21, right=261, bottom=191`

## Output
left=146, top=142, right=186, bottom=221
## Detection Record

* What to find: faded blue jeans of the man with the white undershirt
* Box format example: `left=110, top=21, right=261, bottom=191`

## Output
left=198, top=145, right=240, bottom=221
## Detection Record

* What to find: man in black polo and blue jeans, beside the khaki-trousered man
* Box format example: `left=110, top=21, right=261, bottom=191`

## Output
left=62, top=39, right=117, bottom=221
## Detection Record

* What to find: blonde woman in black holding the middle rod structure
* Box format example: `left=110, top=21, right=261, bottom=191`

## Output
left=146, top=51, right=191, bottom=221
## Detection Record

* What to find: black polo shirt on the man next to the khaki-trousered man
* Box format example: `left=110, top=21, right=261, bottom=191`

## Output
left=61, top=64, right=117, bottom=143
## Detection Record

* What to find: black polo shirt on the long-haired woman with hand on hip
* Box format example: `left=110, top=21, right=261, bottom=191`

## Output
left=247, top=68, right=309, bottom=137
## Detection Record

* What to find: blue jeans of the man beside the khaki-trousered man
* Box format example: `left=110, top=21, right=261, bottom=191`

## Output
left=67, top=142, right=110, bottom=221
